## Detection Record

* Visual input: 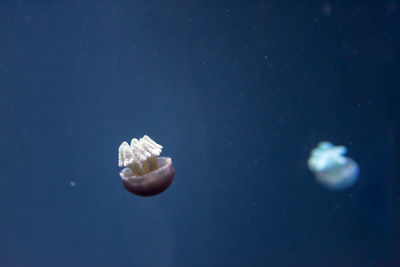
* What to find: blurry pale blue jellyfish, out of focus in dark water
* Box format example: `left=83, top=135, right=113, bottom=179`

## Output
left=308, top=142, right=360, bottom=191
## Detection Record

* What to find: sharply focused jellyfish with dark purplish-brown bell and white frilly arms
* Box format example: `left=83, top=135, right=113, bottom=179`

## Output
left=119, top=135, right=175, bottom=196
